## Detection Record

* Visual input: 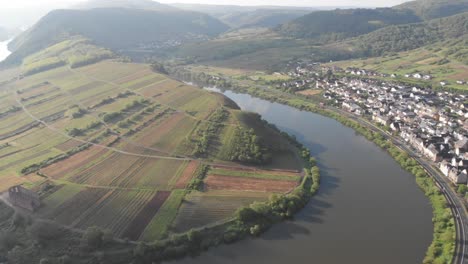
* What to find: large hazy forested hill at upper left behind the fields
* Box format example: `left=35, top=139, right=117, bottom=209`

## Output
left=6, top=8, right=228, bottom=63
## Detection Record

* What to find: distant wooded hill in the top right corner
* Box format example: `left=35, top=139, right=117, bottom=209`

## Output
left=394, top=0, right=468, bottom=20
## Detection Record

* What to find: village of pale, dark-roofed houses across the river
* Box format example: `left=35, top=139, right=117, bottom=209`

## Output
left=279, top=63, right=468, bottom=185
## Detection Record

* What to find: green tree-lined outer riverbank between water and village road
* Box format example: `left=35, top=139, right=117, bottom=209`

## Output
left=170, top=67, right=455, bottom=263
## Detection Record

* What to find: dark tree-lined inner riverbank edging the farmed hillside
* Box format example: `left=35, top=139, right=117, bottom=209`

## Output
left=133, top=135, right=320, bottom=263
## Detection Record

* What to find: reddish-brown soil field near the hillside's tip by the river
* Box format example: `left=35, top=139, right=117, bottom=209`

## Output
left=205, top=175, right=298, bottom=193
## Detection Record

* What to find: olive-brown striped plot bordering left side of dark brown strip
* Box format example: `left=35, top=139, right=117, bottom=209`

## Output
left=74, top=190, right=155, bottom=237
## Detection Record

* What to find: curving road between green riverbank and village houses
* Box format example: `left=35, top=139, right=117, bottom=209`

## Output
left=334, top=107, right=468, bottom=264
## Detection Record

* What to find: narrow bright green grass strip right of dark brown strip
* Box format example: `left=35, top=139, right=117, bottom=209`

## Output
left=142, top=190, right=186, bottom=241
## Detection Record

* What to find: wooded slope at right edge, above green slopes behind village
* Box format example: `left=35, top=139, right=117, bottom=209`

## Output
left=350, top=12, right=468, bottom=56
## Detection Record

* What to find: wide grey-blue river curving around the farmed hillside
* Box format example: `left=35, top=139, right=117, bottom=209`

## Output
left=173, top=88, right=433, bottom=264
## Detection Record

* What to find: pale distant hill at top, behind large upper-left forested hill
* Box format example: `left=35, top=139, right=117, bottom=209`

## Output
left=74, top=0, right=177, bottom=11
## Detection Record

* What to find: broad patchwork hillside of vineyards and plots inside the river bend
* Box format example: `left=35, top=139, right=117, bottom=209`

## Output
left=0, top=39, right=302, bottom=241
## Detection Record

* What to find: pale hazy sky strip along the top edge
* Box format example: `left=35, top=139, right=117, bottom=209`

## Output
left=0, top=0, right=406, bottom=9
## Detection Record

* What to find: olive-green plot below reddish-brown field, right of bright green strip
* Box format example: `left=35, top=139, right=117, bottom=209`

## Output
left=174, top=191, right=270, bottom=232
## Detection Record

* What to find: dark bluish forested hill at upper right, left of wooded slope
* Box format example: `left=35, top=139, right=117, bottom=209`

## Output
left=276, top=8, right=421, bottom=41
